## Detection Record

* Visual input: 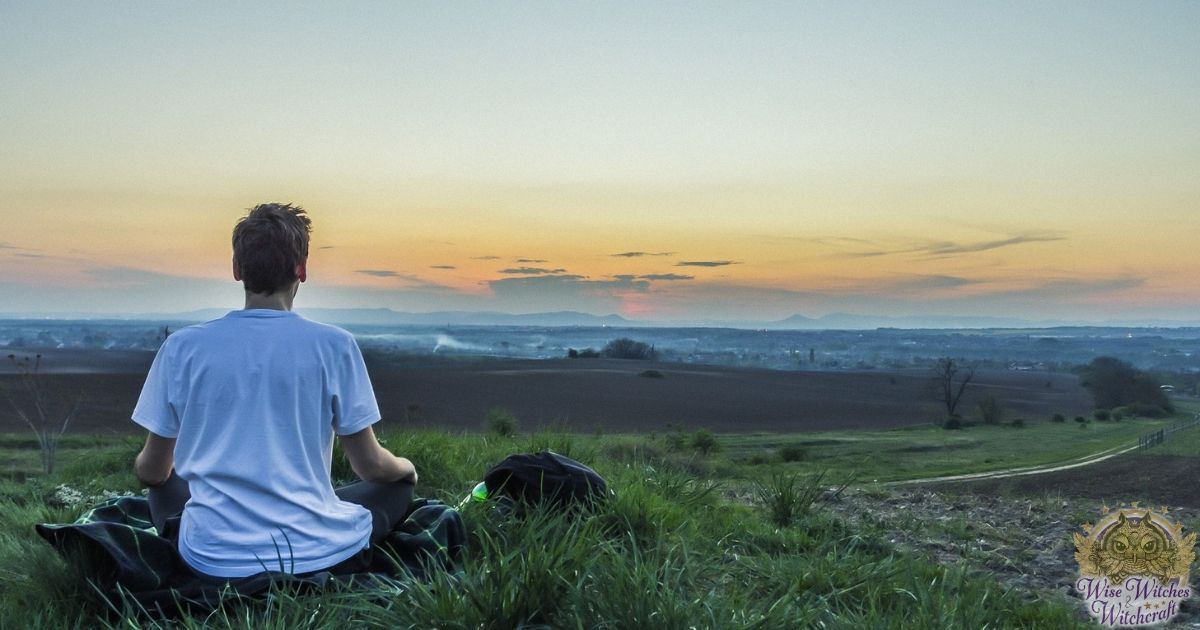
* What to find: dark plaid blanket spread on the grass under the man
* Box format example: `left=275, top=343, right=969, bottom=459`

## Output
left=36, top=497, right=466, bottom=616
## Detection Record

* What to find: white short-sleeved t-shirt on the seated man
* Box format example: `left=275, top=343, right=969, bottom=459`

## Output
left=133, top=308, right=379, bottom=577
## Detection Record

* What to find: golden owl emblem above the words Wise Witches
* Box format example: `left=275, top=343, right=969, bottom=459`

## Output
left=1073, top=504, right=1196, bottom=586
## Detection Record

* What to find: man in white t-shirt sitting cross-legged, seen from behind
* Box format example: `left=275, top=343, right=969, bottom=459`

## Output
left=132, top=204, right=418, bottom=580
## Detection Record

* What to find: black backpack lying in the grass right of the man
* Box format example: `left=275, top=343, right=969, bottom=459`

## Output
left=484, top=451, right=608, bottom=506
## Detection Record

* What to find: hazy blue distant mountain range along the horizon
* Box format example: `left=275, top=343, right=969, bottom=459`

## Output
left=0, top=308, right=1200, bottom=330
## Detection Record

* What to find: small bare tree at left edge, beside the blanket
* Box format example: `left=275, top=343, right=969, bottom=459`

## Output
left=0, top=354, right=83, bottom=474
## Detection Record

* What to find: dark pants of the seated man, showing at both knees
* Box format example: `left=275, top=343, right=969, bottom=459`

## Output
left=149, top=470, right=414, bottom=574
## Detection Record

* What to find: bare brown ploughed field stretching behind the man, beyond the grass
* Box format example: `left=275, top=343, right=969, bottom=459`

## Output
left=0, top=352, right=1091, bottom=433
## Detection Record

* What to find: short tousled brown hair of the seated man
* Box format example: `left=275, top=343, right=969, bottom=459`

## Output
left=233, top=204, right=312, bottom=294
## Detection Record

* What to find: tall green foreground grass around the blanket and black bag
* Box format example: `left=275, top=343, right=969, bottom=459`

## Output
left=0, top=430, right=1085, bottom=629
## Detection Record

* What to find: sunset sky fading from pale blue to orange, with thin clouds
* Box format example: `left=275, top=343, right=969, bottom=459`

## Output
left=0, top=0, right=1200, bottom=322
